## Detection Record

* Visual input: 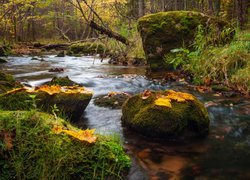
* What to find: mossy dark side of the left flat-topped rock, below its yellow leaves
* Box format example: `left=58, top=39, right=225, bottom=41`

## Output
left=0, top=89, right=92, bottom=121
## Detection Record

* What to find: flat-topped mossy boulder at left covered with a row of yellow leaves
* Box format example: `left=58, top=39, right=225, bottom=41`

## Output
left=0, top=85, right=93, bottom=121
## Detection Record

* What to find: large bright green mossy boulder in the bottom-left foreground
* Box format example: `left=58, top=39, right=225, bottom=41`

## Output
left=0, top=111, right=131, bottom=180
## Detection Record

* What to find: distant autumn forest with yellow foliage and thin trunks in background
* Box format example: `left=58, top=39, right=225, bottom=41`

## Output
left=0, top=0, right=250, bottom=41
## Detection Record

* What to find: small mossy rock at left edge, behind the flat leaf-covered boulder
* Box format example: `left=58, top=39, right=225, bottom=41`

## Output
left=0, top=71, right=22, bottom=94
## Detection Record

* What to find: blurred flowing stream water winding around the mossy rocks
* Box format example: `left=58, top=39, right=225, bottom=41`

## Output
left=0, top=56, right=250, bottom=180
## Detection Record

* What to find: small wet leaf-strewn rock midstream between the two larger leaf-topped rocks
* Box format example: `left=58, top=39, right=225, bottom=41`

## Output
left=94, top=92, right=130, bottom=109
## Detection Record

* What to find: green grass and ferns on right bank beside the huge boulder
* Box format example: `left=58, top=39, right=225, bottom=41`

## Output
left=165, top=27, right=250, bottom=94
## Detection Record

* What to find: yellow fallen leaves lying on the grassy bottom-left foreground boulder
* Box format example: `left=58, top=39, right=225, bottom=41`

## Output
left=52, top=125, right=97, bottom=144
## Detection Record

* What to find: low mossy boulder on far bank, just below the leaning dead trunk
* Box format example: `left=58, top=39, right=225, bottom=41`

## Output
left=67, top=42, right=107, bottom=55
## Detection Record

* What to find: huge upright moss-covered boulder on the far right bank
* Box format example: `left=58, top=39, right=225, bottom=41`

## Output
left=138, top=11, right=234, bottom=70
